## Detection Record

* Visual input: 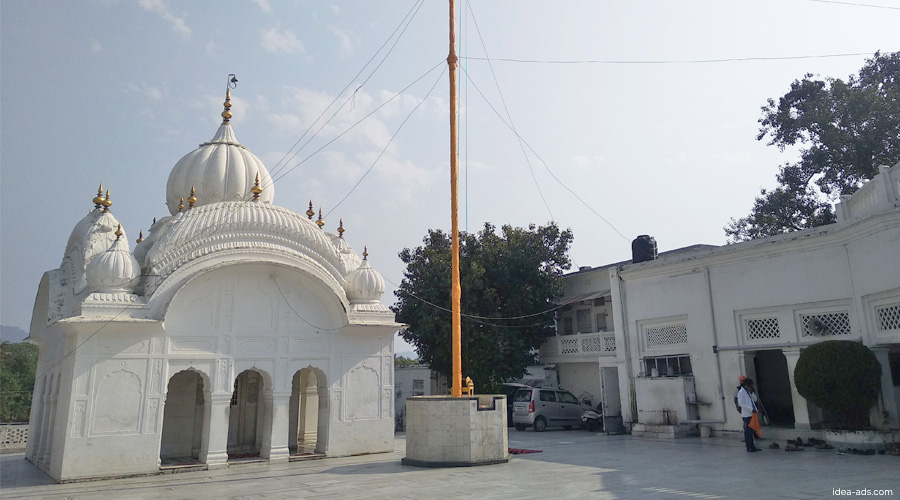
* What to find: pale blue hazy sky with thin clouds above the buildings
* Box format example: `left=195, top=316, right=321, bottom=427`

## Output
left=0, top=0, right=900, bottom=352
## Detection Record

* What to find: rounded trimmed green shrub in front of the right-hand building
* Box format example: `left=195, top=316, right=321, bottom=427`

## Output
left=794, top=340, right=881, bottom=429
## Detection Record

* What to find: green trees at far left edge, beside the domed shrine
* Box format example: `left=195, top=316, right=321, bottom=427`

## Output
left=0, top=340, right=38, bottom=422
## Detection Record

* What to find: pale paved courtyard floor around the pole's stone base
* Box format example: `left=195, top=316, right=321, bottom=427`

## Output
left=0, top=429, right=900, bottom=500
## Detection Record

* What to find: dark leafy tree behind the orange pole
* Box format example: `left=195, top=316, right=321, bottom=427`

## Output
left=392, top=223, right=572, bottom=392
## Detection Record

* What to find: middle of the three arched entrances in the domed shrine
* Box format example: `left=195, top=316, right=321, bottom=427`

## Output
left=228, top=370, right=267, bottom=459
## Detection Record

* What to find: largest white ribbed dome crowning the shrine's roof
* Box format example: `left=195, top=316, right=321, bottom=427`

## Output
left=166, top=121, right=275, bottom=215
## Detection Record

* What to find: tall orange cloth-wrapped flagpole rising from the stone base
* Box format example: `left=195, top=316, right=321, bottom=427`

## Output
left=447, top=0, right=462, bottom=398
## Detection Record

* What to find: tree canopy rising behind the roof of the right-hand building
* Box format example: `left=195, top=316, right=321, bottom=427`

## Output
left=725, top=52, right=900, bottom=242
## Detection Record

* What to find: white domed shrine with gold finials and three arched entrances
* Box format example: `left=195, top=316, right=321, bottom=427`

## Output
left=26, top=90, right=399, bottom=481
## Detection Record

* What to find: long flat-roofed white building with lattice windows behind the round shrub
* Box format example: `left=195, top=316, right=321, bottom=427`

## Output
left=541, top=164, right=900, bottom=436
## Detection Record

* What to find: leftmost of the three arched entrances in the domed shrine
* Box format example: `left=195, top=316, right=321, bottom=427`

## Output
left=159, top=370, right=209, bottom=467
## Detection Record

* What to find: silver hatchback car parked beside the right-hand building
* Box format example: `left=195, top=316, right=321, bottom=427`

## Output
left=512, top=387, right=592, bottom=432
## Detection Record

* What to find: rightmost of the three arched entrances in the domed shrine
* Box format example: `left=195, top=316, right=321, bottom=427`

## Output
left=288, top=366, right=328, bottom=456
